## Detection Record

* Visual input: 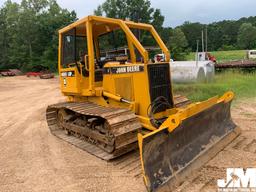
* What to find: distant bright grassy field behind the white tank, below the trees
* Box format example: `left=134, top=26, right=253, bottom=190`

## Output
left=186, top=50, right=246, bottom=63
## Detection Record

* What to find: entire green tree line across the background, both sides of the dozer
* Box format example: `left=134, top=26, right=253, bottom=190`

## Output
left=0, top=0, right=256, bottom=71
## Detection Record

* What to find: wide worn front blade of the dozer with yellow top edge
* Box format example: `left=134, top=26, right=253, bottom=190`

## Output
left=138, top=92, right=240, bottom=191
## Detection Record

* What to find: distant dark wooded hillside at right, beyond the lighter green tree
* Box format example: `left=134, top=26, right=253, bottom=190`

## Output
left=178, top=17, right=256, bottom=51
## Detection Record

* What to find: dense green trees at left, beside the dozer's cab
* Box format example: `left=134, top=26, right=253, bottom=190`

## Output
left=0, top=0, right=77, bottom=71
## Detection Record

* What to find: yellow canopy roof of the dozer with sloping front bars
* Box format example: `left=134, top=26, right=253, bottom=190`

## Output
left=59, top=16, right=170, bottom=63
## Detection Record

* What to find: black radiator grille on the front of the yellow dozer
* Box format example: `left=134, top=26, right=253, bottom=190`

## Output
left=148, top=63, right=173, bottom=112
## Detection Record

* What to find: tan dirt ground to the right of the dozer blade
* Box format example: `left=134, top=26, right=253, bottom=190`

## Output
left=175, top=98, right=256, bottom=192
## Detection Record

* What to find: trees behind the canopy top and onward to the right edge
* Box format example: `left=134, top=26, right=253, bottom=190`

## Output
left=94, top=0, right=256, bottom=60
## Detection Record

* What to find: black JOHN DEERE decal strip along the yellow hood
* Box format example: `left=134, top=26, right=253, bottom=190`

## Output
left=105, top=65, right=144, bottom=74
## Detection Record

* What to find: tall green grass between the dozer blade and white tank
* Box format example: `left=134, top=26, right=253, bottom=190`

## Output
left=173, top=71, right=256, bottom=101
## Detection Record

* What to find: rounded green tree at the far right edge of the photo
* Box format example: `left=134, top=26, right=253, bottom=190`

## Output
left=237, top=23, right=256, bottom=49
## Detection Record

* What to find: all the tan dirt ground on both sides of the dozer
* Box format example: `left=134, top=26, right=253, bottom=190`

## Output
left=0, top=77, right=256, bottom=192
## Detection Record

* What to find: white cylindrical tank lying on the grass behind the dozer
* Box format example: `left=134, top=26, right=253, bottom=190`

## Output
left=170, top=61, right=215, bottom=83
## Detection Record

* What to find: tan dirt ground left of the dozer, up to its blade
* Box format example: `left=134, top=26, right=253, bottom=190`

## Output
left=0, top=77, right=145, bottom=192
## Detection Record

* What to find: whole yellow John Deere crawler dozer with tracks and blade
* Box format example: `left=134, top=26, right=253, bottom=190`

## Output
left=46, top=16, right=239, bottom=191
